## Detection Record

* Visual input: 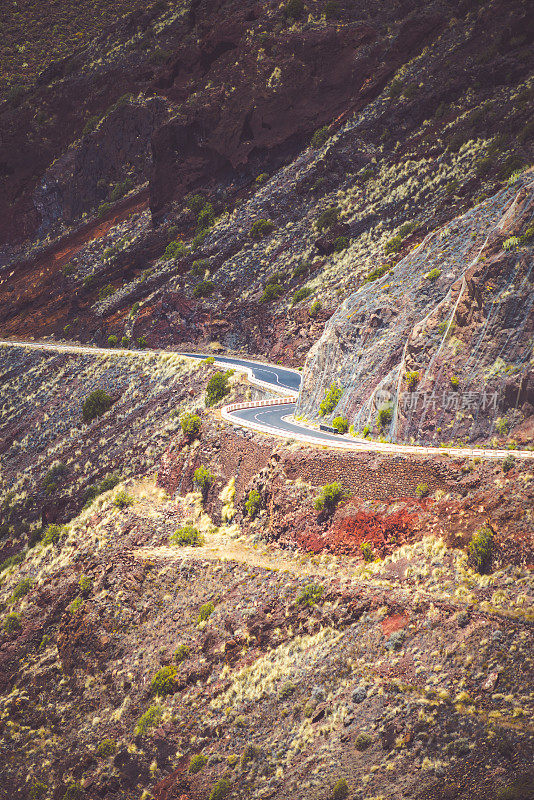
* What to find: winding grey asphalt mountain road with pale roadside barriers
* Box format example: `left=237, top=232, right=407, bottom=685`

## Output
left=0, top=340, right=534, bottom=459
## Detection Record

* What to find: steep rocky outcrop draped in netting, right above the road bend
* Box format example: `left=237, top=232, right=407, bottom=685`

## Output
left=299, top=172, right=534, bottom=443
